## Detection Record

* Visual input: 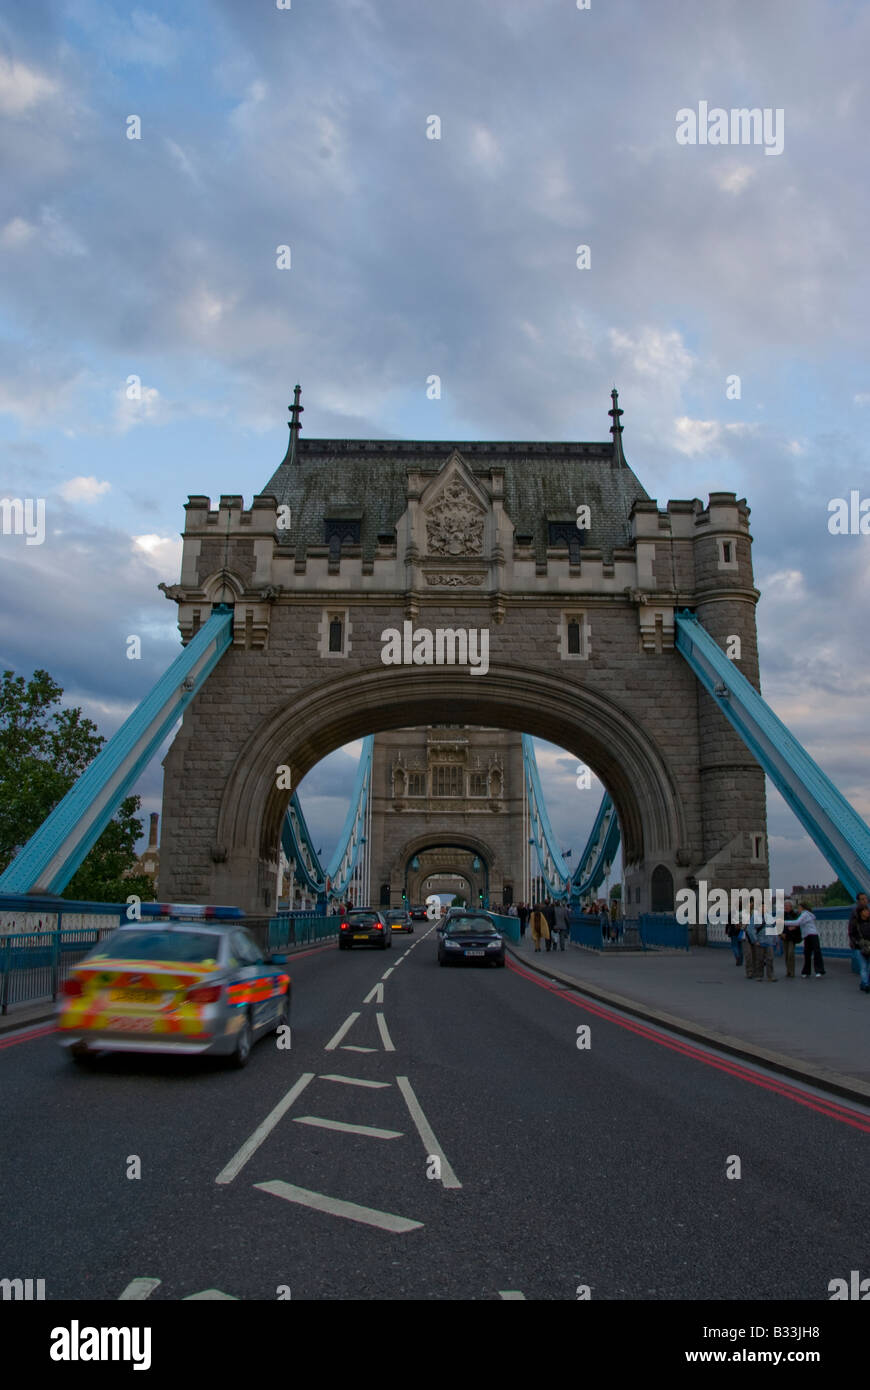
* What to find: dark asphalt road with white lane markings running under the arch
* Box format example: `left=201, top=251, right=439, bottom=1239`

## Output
left=0, top=929, right=870, bottom=1301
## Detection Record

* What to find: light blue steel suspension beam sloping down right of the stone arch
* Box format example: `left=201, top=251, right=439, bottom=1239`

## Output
left=674, top=609, right=870, bottom=895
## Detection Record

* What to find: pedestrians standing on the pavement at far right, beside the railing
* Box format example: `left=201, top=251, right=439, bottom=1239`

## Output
left=725, top=892, right=870, bottom=994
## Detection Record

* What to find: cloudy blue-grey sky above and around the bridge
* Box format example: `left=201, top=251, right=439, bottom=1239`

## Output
left=0, top=0, right=870, bottom=887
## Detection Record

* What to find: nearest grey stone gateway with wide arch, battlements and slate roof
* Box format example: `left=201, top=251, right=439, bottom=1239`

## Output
left=161, top=436, right=766, bottom=913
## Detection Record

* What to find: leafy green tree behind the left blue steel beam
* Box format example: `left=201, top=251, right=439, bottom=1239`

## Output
left=0, top=670, right=154, bottom=902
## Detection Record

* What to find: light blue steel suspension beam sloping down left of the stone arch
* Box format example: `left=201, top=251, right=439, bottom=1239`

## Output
left=0, top=603, right=232, bottom=894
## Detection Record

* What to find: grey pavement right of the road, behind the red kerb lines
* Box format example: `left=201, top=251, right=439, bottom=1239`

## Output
left=507, top=933, right=870, bottom=1102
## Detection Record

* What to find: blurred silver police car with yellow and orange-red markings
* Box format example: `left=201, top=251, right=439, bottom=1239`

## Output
left=57, top=922, right=290, bottom=1066
